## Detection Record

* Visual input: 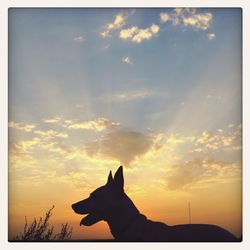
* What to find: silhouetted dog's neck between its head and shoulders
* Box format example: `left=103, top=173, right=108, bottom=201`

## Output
left=104, top=193, right=142, bottom=239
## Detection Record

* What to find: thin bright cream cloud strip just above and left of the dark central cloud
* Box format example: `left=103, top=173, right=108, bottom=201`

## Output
left=65, top=117, right=120, bottom=131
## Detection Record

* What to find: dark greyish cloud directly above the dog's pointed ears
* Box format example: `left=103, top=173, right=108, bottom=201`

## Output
left=86, top=129, right=154, bottom=166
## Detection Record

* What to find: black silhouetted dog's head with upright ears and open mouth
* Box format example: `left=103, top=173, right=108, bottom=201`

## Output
left=72, top=166, right=124, bottom=226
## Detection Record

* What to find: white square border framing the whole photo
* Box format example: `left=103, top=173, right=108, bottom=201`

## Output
left=0, top=0, right=250, bottom=250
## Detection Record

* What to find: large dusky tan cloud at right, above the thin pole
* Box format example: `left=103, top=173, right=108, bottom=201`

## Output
left=167, top=158, right=241, bottom=190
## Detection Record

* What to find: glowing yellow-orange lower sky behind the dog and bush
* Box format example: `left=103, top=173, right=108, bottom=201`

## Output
left=9, top=143, right=241, bottom=239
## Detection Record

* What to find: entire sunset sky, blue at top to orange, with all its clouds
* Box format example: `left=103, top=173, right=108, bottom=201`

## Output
left=9, top=8, right=242, bottom=239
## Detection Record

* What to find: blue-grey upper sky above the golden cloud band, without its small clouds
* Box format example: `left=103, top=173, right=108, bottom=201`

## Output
left=9, top=9, right=241, bottom=133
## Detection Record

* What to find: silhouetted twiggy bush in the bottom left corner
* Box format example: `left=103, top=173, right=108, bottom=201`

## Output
left=13, top=206, right=72, bottom=241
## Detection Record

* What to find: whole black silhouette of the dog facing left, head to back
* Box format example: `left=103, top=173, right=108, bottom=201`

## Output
left=72, top=166, right=238, bottom=242
